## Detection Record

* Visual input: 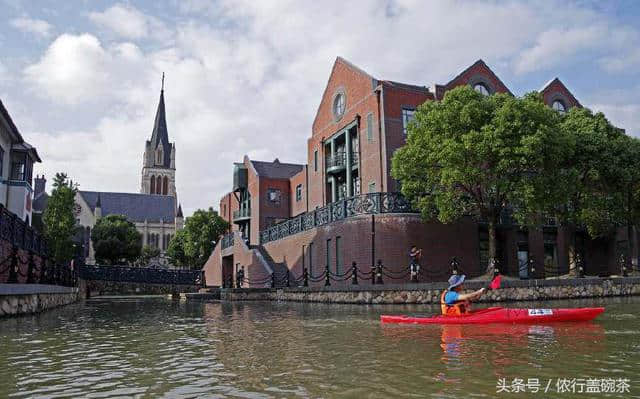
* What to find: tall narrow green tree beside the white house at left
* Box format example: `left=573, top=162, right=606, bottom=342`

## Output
left=43, top=173, right=78, bottom=264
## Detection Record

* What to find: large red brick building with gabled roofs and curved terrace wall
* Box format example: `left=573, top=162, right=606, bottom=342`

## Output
left=204, top=57, right=626, bottom=285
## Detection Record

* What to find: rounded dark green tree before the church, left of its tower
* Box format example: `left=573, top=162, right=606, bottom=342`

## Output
left=91, top=215, right=142, bottom=265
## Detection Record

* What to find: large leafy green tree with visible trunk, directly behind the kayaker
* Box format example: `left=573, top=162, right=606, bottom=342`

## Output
left=392, top=86, right=569, bottom=272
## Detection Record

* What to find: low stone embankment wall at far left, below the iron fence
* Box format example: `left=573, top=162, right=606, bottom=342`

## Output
left=0, top=284, right=80, bottom=317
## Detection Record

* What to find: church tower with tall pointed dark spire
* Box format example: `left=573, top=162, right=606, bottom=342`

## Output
left=140, top=73, right=176, bottom=197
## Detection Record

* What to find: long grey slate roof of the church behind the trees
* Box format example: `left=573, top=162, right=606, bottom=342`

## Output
left=78, top=191, right=176, bottom=223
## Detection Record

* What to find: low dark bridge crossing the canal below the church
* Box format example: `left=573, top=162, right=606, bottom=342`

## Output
left=78, top=265, right=203, bottom=297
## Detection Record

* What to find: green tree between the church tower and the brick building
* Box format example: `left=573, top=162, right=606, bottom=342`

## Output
left=167, top=208, right=229, bottom=269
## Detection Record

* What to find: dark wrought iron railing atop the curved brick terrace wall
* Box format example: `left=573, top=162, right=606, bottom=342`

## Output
left=258, top=193, right=415, bottom=248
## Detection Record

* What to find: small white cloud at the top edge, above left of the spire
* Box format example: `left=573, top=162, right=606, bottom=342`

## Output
left=89, top=4, right=166, bottom=39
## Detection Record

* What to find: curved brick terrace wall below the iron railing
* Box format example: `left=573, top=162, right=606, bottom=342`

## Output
left=264, top=215, right=479, bottom=286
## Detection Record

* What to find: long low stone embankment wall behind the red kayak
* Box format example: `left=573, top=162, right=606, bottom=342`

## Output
left=214, top=277, right=640, bottom=304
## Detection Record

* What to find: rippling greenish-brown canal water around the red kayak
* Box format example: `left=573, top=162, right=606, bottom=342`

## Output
left=0, top=298, right=640, bottom=398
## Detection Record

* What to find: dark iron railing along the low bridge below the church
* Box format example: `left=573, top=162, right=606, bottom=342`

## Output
left=79, top=265, right=202, bottom=285
